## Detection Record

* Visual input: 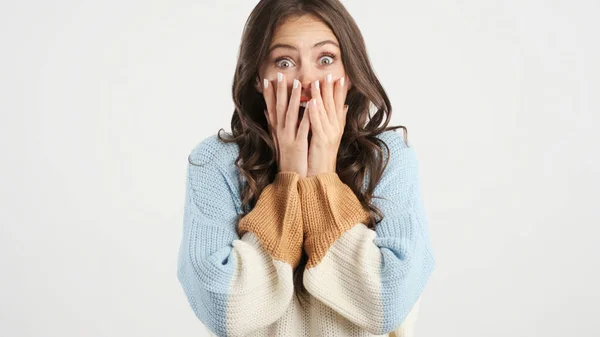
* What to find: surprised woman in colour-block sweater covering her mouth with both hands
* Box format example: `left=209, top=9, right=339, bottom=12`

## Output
left=178, top=0, right=435, bottom=336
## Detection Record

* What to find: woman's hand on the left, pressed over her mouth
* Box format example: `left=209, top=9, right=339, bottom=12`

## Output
left=263, top=73, right=310, bottom=178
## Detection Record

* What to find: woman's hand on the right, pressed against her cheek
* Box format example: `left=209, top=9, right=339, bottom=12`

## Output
left=305, top=74, right=349, bottom=177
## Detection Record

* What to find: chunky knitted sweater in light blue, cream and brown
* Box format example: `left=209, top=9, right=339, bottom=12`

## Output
left=177, top=131, right=435, bottom=337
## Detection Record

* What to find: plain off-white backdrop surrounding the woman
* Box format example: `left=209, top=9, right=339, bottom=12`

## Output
left=0, top=0, right=600, bottom=337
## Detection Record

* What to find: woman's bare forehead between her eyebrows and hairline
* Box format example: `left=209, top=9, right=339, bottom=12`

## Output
left=271, top=15, right=338, bottom=47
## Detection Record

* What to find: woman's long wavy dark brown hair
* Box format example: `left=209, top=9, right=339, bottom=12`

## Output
left=218, top=0, right=408, bottom=304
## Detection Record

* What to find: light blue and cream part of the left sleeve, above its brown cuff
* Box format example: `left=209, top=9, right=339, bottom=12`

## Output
left=177, top=136, right=293, bottom=336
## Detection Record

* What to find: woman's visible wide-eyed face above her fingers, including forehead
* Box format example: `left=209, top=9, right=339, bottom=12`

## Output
left=257, top=15, right=351, bottom=112
